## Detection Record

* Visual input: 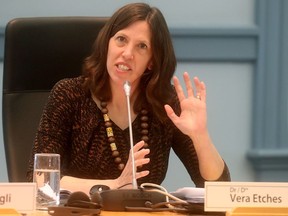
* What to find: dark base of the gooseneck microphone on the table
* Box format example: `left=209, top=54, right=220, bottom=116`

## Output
left=100, top=189, right=166, bottom=211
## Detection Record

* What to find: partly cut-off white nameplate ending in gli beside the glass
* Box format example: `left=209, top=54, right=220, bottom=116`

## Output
left=0, top=183, right=36, bottom=213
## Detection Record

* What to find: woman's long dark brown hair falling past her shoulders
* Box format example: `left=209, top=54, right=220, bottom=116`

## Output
left=83, top=3, right=176, bottom=122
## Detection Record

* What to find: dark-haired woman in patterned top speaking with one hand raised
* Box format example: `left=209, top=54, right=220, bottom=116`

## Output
left=27, top=3, right=230, bottom=192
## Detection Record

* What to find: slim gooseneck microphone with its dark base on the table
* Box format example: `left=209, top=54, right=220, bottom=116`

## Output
left=100, top=81, right=166, bottom=211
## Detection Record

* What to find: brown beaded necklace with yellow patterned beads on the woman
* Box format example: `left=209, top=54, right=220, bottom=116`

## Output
left=100, top=101, right=149, bottom=170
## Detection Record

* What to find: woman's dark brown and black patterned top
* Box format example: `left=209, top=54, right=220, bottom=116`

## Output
left=27, top=77, right=230, bottom=187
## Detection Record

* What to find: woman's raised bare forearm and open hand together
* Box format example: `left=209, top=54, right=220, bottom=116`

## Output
left=165, top=72, right=224, bottom=180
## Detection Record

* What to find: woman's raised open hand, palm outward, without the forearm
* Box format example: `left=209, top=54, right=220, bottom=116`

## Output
left=165, top=72, right=207, bottom=137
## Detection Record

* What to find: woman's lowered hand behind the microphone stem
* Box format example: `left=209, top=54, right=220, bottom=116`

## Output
left=115, top=141, right=150, bottom=188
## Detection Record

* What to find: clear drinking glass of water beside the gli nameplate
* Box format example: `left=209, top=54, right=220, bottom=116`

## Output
left=33, top=153, right=60, bottom=210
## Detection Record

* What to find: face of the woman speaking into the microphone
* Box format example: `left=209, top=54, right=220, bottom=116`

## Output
left=107, top=21, right=152, bottom=87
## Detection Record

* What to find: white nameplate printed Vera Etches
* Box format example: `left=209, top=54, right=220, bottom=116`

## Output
left=204, top=182, right=288, bottom=211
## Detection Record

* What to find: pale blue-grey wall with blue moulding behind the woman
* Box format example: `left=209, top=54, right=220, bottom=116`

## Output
left=0, top=0, right=288, bottom=191
